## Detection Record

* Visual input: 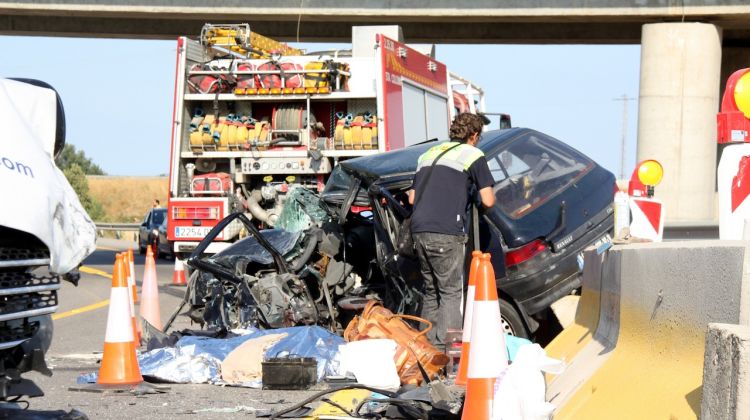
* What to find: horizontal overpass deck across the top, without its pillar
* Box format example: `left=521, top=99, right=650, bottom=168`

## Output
left=0, top=0, right=750, bottom=46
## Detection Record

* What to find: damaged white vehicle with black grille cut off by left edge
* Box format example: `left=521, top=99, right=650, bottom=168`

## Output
left=0, top=79, right=96, bottom=401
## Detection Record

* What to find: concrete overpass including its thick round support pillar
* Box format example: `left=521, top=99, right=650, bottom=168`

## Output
left=0, top=0, right=750, bottom=221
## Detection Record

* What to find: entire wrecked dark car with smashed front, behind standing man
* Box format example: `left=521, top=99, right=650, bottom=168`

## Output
left=179, top=128, right=615, bottom=337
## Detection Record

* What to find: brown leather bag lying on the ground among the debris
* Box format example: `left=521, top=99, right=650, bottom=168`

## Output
left=344, top=300, right=448, bottom=385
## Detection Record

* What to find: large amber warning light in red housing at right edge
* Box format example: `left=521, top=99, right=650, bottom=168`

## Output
left=716, top=68, right=750, bottom=144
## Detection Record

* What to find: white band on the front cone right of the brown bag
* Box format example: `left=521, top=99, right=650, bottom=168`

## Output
left=467, top=300, right=508, bottom=379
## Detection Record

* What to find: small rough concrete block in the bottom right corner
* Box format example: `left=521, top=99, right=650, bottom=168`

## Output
left=701, top=324, right=750, bottom=420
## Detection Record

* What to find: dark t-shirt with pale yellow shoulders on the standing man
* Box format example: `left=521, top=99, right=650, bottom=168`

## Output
left=411, top=142, right=494, bottom=235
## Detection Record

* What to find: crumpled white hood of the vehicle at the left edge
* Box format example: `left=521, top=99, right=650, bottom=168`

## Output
left=0, top=79, right=96, bottom=274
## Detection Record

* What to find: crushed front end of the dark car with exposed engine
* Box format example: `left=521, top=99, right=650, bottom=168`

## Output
left=181, top=187, right=394, bottom=331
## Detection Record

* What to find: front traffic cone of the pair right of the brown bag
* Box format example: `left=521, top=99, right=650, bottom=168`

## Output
left=461, top=254, right=508, bottom=420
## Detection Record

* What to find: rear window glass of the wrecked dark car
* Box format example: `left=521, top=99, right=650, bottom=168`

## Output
left=486, top=132, right=593, bottom=219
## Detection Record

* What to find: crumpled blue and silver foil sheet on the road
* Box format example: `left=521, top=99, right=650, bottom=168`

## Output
left=138, top=326, right=344, bottom=387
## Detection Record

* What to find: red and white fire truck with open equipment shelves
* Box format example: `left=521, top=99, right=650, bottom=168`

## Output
left=167, top=24, right=484, bottom=258
